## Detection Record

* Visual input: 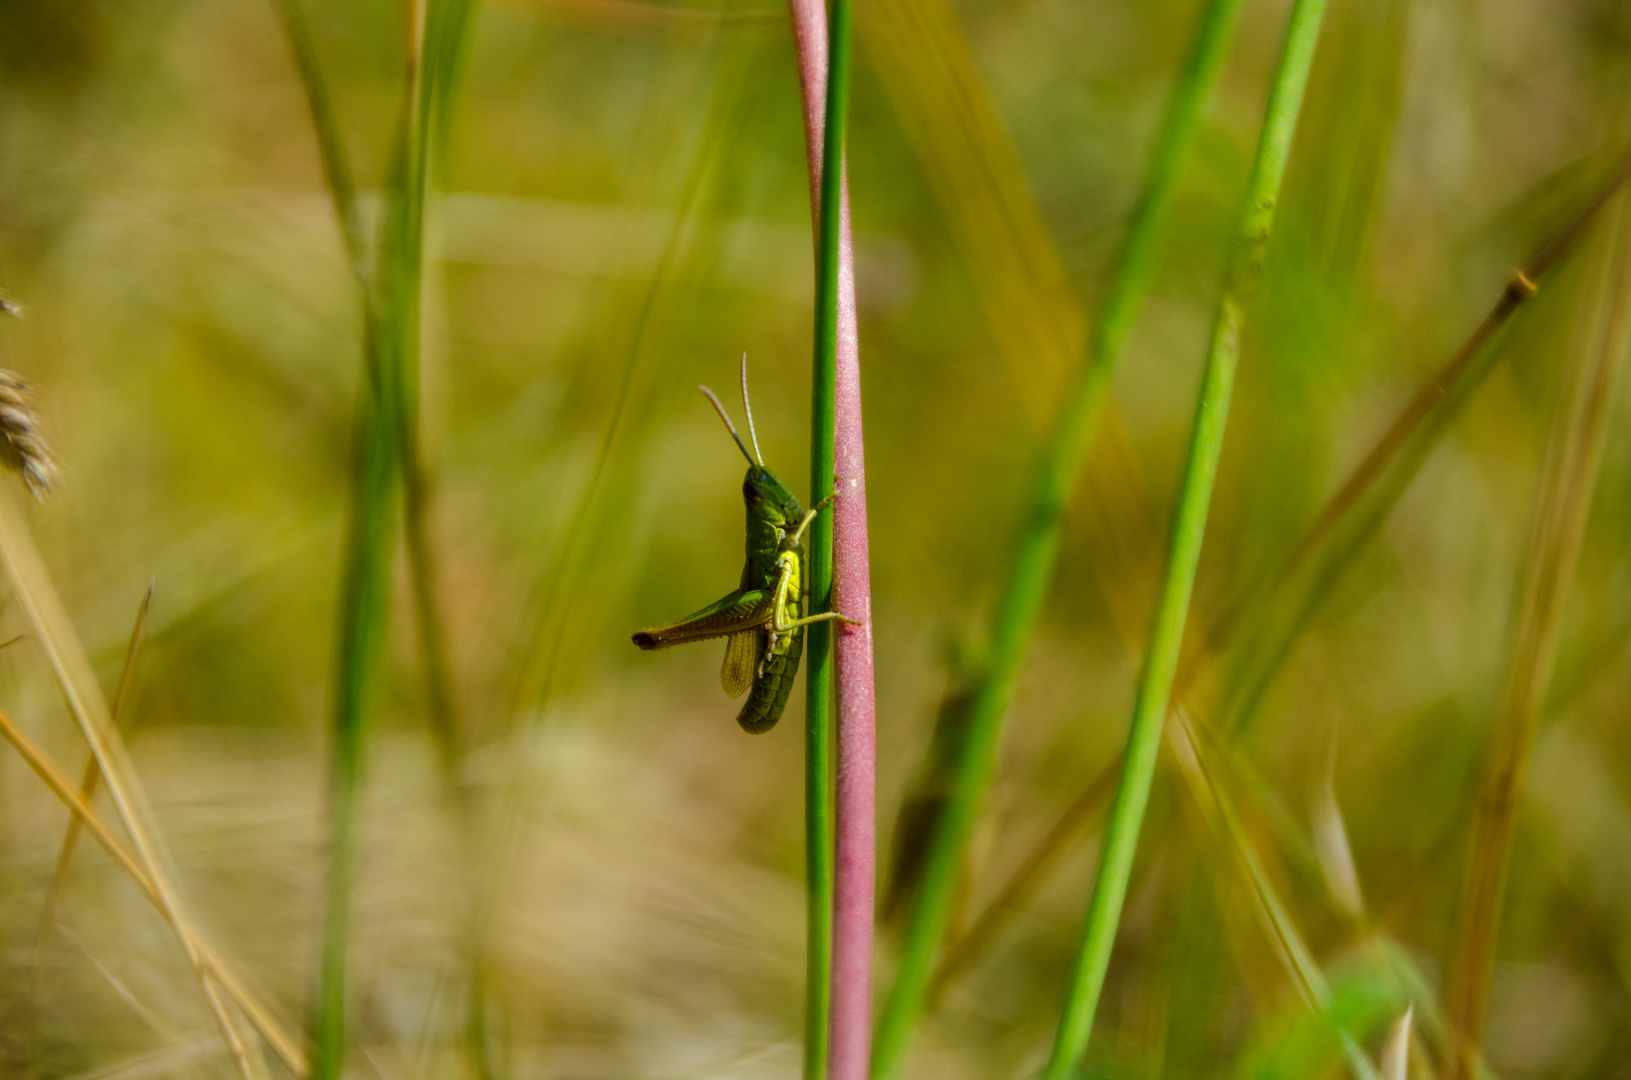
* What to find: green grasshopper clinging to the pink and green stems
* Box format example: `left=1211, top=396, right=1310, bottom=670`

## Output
left=633, top=356, right=860, bottom=734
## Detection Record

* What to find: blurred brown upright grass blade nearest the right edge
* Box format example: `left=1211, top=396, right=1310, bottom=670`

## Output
left=1443, top=192, right=1631, bottom=1080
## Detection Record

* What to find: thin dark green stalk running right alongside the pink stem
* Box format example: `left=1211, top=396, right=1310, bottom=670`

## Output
left=804, top=0, right=851, bottom=1080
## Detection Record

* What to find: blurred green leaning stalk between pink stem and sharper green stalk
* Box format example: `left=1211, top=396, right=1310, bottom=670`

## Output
left=873, top=0, right=1241, bottom=1078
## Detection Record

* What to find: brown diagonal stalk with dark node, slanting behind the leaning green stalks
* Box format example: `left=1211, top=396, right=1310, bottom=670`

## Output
left=936, top=143, right=1631, bottom=982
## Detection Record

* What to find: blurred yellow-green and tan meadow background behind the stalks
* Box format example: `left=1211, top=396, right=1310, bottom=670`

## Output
left=0, top=0, right=1631, bottom=1080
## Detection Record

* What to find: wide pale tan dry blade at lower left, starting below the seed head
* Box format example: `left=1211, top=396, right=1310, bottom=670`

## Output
left=0, top=493, right=265, bottom=1080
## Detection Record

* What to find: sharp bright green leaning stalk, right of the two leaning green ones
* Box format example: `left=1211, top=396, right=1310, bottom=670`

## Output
left=1042, top=0, right=1326, bottom=1080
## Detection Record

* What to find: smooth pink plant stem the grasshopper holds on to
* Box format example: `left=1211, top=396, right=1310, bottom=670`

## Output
left=788, top=0, right=877, bottom=1080
